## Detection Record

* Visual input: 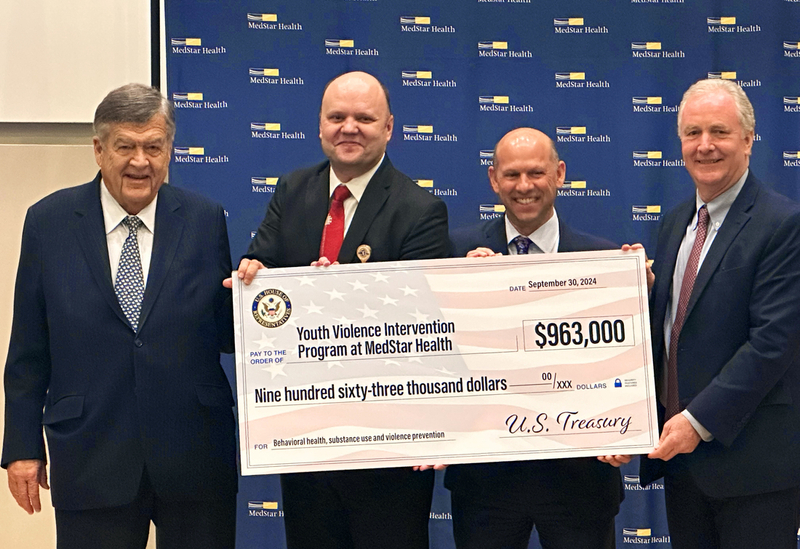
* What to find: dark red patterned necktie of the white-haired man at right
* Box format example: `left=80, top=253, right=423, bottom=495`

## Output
left=667, top=206, right=708, bottom=419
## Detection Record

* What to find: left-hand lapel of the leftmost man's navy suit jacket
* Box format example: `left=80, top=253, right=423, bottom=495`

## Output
left=72, top=172, right=128, bottom=324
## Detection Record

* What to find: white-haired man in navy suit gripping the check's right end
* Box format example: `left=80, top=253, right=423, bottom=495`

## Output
left=641, top=80, right=800, bottom=549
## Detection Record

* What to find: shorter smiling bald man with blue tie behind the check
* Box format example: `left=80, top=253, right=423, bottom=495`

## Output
left=445, top=128, right=623, bottom=549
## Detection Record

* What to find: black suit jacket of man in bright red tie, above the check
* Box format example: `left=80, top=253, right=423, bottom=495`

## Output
left=246, top=156, right=449, bottom=267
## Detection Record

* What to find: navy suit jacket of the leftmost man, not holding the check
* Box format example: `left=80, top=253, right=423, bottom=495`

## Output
left=2, top=174, right=237, bottom=510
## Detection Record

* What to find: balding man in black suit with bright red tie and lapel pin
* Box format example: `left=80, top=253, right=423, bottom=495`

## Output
left=230, top=72, right=449, bottom=549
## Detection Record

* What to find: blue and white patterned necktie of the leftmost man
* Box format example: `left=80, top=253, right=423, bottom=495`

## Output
left=114, top=215, right=144, bottom=332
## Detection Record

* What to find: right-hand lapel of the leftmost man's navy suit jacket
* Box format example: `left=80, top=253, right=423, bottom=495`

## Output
left=139, top=185, right=185, bottom=331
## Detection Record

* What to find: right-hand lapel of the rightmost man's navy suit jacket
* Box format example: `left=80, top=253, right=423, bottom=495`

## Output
left=686, top=173, right=758, bottom=317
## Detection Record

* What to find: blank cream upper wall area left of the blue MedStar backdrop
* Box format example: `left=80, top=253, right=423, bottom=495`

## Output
left=0, top=0, right=150, bottom=122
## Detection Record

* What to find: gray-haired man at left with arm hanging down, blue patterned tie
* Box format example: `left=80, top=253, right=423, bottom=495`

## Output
left=2, top=84, right=237, bottom=549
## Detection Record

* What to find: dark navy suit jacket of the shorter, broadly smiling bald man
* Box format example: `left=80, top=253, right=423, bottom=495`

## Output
left=444, top=216, right=624, bottom=519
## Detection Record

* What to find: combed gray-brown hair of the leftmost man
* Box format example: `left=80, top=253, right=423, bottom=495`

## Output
left=93, top=84, right=175, bottom=141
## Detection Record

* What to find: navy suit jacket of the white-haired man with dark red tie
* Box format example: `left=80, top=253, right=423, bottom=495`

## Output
left=641, top=172, right=800, bottom=497
